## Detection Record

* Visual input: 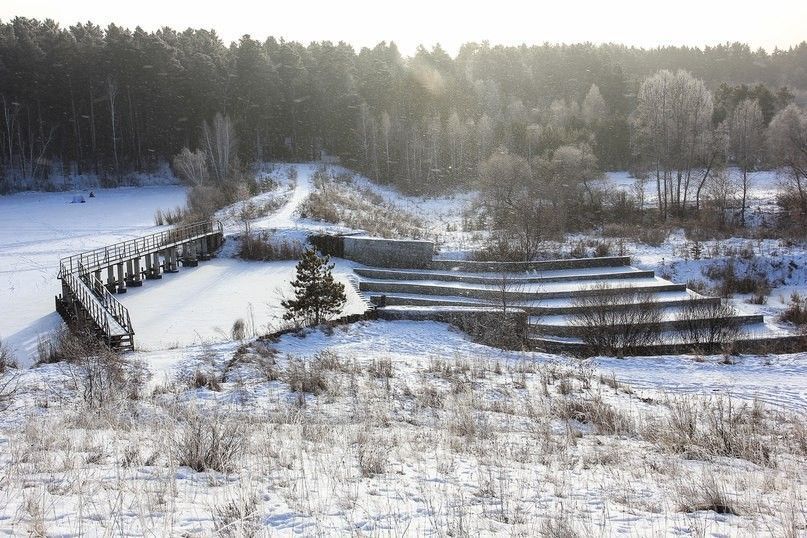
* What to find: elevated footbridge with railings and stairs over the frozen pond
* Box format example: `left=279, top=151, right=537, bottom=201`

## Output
left=56, top=221, right=224, bottom=349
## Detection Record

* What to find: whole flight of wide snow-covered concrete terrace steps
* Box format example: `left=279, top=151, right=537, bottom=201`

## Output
left=355, top=257, right=798, bottom=355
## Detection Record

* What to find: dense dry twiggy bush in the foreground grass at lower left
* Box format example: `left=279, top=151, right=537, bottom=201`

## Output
left=173, top=412, right=247, bottom=472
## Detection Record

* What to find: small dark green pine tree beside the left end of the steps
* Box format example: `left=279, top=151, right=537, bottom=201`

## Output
left=281, top=248, right=347, bottom=325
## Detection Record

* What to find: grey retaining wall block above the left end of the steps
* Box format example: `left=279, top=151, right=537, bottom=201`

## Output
left=343, top=236, right=434, bottom=269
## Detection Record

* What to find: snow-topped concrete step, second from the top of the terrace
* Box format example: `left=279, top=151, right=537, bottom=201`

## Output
left=353, top=265, right=655, bottom=286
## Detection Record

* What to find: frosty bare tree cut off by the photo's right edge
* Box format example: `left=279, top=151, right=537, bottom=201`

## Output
left=768, top=104, right=807, bottom=216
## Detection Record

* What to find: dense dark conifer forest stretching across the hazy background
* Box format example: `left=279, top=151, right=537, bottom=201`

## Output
left=0, top=18, right=807, bottom=193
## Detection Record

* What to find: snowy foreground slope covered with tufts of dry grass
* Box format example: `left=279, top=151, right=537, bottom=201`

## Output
left=0, top=341, right=807, bottom=536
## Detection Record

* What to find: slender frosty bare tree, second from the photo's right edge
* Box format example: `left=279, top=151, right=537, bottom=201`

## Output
left=729, top=99, right=764, bottom=226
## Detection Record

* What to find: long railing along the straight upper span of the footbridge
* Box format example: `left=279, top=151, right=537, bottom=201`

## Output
left=59, top=220, right=224, bottom=278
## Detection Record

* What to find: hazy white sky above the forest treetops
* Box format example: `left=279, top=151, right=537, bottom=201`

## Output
left=0, top=0, right=807, bottom=54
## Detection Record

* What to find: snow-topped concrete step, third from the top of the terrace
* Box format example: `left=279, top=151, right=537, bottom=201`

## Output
left=359, top=277, right=686, bottom=301
